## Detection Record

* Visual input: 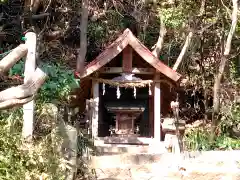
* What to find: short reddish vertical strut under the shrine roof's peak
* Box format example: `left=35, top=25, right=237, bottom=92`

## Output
left=122, top=46, right=132, bottom=73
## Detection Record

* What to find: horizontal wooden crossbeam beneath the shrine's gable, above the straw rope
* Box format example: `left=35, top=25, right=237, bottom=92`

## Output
left=100, top=67, right=156, bottom=74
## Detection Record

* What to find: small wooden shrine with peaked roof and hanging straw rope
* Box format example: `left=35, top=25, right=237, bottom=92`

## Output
left=80, top=29, right=181, bottom=143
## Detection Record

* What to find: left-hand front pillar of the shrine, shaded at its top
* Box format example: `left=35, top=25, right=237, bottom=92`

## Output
left=91, top=81, right=99, bottom=138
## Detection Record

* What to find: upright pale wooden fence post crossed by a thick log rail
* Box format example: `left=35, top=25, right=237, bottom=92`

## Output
left=22, top=32, right=37, bottom=141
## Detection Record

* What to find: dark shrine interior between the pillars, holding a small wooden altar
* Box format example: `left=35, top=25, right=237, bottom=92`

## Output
left=98, top=83, right=151, bottom=137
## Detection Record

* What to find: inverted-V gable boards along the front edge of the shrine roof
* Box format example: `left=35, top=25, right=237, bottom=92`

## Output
left=80, top=29, right=181, bottom=82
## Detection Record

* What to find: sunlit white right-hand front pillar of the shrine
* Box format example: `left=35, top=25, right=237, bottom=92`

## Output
left=154, top=75, right=161, bottom=142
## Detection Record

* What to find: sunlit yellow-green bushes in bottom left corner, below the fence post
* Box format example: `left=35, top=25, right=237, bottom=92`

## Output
left=0, top=109, right=64, bottom=180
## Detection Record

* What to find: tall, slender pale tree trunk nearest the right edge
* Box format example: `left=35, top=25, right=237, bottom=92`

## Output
left=211, top=0, right=238, bottom=142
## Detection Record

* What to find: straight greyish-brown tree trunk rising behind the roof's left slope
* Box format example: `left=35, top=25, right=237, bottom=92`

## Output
left=77, top=0, right=89, bottom=73
